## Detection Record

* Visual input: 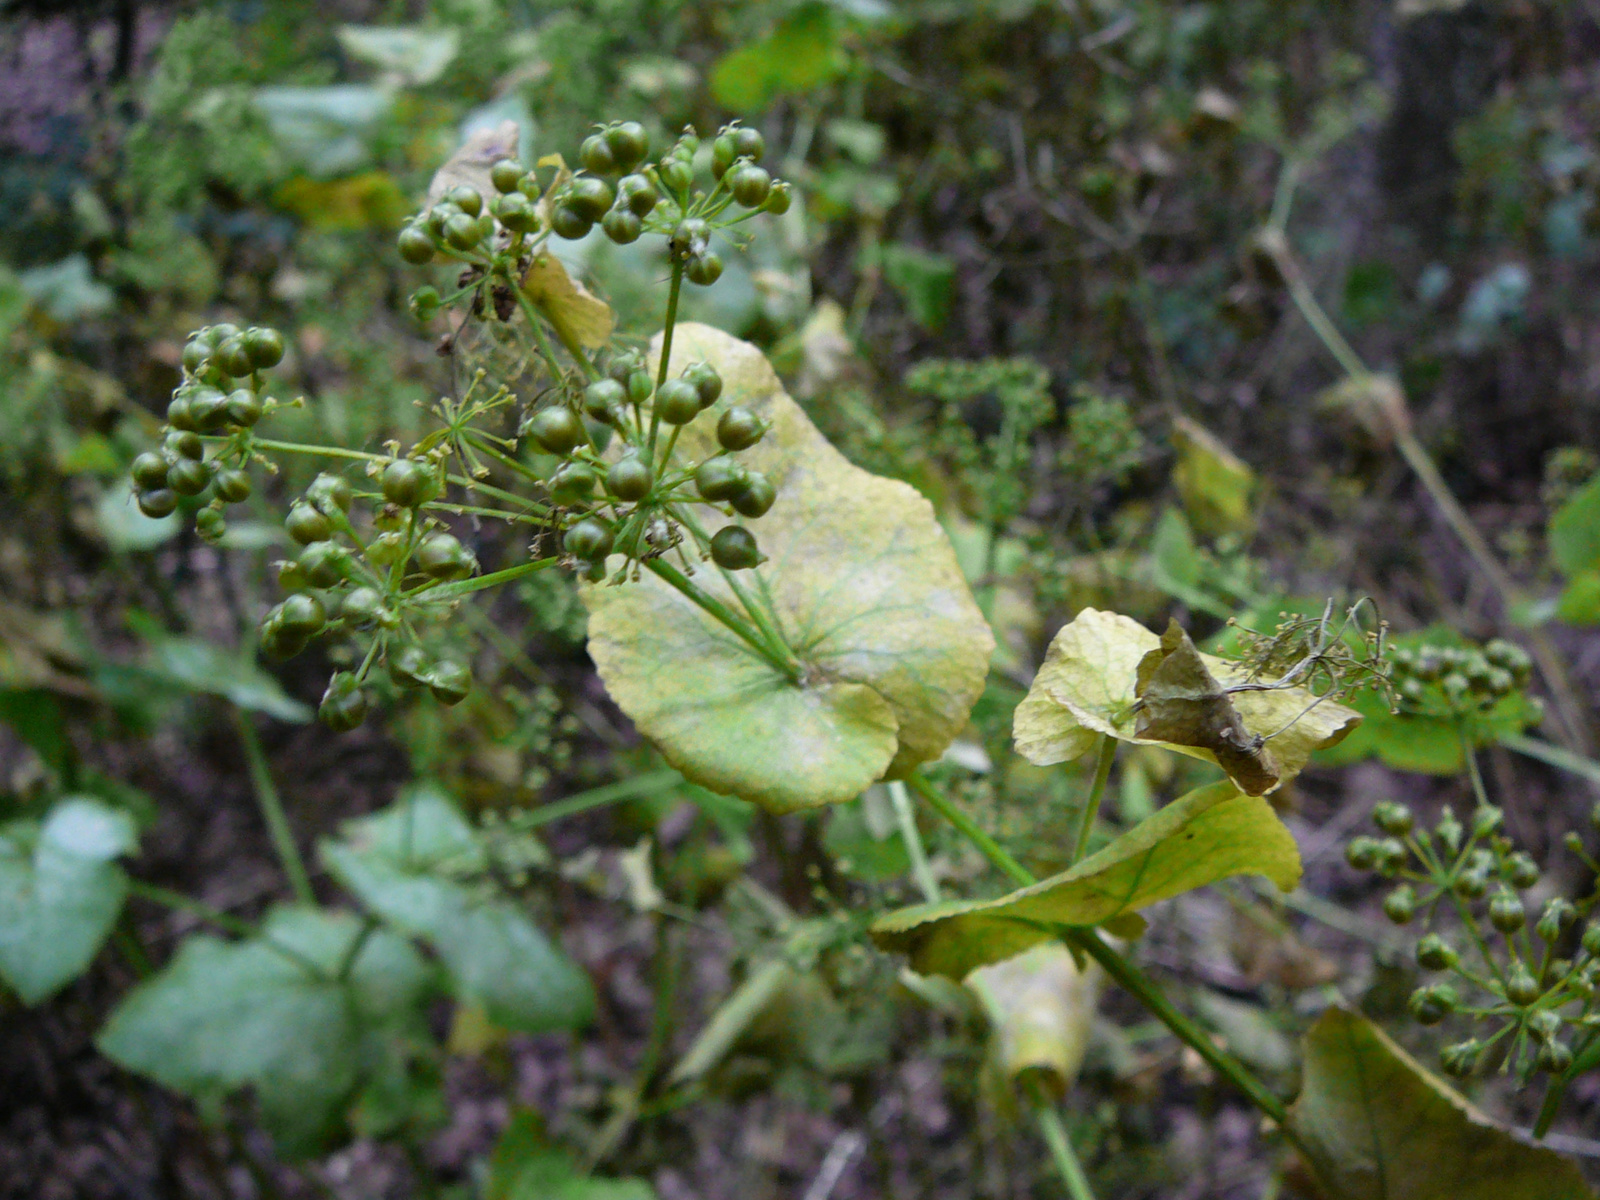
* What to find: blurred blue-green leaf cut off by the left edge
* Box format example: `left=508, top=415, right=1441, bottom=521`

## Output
left=0, top=797, right=138, bottom=1005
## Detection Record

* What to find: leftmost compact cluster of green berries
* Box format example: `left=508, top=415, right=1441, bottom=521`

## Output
left=133, top=325, right=283, bottom=541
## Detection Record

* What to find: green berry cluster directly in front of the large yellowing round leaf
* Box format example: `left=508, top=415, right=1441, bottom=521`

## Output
left=522, top=352, right=778, bottom=582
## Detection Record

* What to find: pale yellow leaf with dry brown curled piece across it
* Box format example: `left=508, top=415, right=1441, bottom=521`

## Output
left=1013, top=608, right=1362, bottom=794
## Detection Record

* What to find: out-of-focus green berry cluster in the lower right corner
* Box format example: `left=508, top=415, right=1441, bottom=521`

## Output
left=1346, top=793, right=1600, bottom=1080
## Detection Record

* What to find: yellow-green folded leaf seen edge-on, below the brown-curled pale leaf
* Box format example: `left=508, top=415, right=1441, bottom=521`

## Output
left=872, top=781, right=1301, bottom=979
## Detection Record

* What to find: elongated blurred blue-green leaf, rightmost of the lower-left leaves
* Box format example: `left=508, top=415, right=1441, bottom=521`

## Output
left=322, top=786, right=594, bottom=1034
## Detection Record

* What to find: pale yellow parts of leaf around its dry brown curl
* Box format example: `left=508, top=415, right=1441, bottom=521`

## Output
left=1013, top=608, right=1362, bottom=790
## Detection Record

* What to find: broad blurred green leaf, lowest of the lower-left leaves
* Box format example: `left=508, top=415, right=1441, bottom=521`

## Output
left=98, top=907, right=429, bottom=1155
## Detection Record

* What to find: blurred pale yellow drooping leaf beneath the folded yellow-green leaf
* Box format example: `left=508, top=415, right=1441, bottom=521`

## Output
left=966, top=942, right=1104, bottom=1096
